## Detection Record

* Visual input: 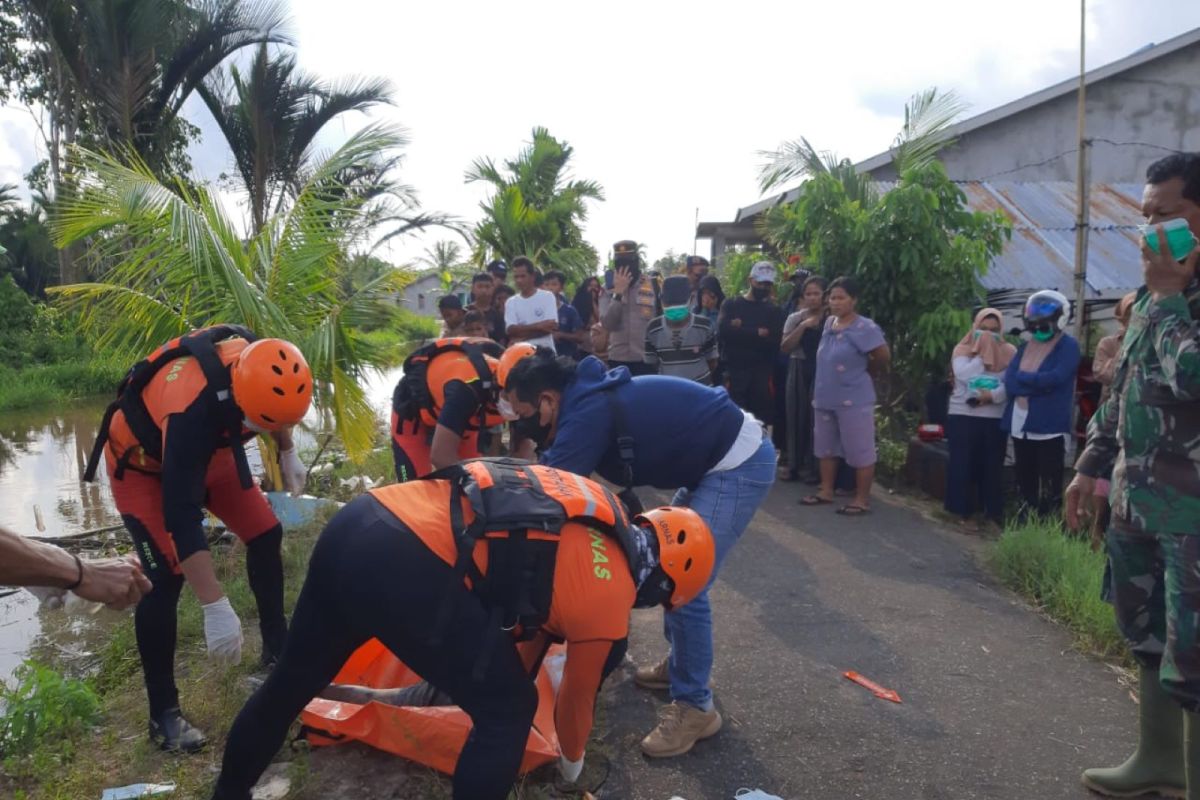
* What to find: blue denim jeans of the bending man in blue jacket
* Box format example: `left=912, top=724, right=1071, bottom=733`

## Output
left=662, top=439, right=776, bottom=711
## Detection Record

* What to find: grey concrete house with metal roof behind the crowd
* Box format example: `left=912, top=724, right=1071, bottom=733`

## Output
left=696, top=29, right=1200, bottom=321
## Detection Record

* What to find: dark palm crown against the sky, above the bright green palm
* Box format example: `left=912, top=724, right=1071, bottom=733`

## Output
left=198, top=43, right=391, bottom=230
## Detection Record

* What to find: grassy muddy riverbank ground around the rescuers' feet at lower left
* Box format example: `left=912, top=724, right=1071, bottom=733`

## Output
left=0, top=503, right=588, bottom=800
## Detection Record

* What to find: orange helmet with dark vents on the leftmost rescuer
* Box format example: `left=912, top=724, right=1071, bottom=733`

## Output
left=230, top=339, right=312, bottom=431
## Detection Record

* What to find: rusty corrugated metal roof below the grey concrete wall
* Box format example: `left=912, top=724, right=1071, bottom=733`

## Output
left=876, top=181, right=1142, bottom=300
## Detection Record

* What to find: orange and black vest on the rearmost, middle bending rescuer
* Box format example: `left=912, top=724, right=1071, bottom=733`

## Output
left=391, top=336, right=504, bottom=431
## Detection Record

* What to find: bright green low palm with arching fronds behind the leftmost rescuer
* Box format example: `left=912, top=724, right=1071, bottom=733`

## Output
left=53, top=126, right=409, bottom=457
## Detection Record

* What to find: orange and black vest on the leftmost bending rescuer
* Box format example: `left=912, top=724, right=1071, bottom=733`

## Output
left=84, top=325, right=257, bottom=489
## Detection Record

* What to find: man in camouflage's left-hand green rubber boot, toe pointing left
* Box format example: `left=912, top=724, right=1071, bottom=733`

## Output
left=1082, top=667, right=1185, bottom=800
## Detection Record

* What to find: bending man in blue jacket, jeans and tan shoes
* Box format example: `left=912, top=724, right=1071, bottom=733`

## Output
left=504, top=348, right=775, bottom=758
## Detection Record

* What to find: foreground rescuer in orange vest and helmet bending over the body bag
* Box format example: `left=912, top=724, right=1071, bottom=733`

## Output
left=214, top=458, right=715, bottom=800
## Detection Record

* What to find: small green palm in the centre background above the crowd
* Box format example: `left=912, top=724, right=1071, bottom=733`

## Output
left=466, top=127, right=604, bottom=278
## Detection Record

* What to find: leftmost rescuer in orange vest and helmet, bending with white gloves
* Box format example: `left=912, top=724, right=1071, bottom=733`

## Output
left=85, top=325, right=312, bottom=752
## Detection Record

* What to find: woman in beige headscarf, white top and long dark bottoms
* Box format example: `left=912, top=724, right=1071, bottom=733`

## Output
left=946, top=308, right=1016, bottom=524
